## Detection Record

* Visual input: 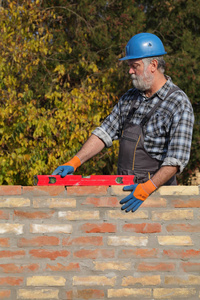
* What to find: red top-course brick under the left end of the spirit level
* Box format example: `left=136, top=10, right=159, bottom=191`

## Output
left=23, top=185, right=66, bottom=197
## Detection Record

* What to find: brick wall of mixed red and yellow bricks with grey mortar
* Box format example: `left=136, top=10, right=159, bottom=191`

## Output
left=0, top=186, right=200, bottom=300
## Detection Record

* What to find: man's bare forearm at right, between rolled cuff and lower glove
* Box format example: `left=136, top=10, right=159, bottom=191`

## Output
left=152, top=166, right=179, bottom=188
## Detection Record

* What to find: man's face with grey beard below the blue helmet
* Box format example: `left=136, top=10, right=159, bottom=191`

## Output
left=128, top=59, right=154, bottom=92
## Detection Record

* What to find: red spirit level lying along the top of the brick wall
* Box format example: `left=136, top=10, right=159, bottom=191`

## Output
left=34, top=175, right=134, bottom=186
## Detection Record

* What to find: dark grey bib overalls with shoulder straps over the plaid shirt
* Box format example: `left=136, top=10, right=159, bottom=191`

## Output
left=117, top=87, right=179, bottom=185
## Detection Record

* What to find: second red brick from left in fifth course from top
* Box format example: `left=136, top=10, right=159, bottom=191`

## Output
left=17, top=236, right=60, bottom=247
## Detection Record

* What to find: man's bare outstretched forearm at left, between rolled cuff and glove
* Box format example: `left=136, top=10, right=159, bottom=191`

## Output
left=76, top=134, right=105, bottom=164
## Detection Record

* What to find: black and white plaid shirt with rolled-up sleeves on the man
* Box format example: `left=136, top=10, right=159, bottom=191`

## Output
left=92, top=76, right=194, bottom=172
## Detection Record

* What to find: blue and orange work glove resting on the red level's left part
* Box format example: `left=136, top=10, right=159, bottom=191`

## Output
left=51, top=156, right=81, bottom=178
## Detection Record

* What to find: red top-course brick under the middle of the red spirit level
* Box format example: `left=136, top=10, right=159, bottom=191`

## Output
left=67, top=186, right=108, bottom=196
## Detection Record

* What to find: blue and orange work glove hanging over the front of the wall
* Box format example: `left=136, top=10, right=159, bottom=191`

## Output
left=120, top=179, right=157, bottom=212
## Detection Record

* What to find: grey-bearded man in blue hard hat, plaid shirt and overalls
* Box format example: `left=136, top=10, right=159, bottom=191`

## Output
left=53, top=33, right=194, bottom=212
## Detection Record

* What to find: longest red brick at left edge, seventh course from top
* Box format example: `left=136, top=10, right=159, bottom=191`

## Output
left=0, top=264, right=39, bottom=273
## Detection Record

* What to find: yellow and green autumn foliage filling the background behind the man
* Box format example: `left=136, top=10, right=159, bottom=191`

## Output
left=0, top=0, right=200, bottom=185
